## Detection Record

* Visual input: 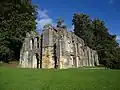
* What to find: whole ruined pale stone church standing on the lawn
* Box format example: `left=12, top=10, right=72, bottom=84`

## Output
left=19, top=27, right=99, bottom=69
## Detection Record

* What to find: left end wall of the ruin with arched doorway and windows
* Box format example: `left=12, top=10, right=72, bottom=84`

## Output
left=19, top=32, right=41, bottom=68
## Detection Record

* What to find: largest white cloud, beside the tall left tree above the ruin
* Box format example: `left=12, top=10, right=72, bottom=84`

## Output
left=36, top=9, right=53, bottom=33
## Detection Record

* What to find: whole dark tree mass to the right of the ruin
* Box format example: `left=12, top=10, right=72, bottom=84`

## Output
left=72, top=13, right=120, bottom=68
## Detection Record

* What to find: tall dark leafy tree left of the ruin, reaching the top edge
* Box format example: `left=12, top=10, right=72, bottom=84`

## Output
left=0, top=0, right=36, bottom=61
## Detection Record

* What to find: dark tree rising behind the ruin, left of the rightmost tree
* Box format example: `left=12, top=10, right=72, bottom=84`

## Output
left=72, top=13, right=94, bottom=48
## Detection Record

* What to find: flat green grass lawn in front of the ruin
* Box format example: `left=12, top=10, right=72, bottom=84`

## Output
left=0, top=68, right=120, bottom=90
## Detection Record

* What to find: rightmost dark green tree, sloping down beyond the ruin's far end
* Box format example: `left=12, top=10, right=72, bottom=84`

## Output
left=92, top=19, right=118, bottom=67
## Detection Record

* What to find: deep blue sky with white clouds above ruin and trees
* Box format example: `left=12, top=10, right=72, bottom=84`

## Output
left=32, top=0, right=120, bottom=43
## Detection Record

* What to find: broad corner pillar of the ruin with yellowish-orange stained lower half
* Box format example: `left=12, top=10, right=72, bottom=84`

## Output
left=42, top=28, right=55, bottom=68
